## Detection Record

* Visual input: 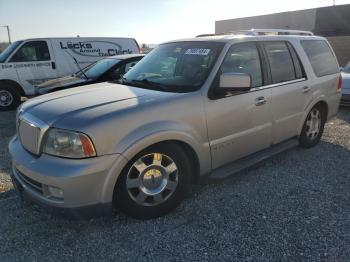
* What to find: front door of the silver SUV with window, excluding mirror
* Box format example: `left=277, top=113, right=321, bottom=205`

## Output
left=205, top=42, right=272, bottom=168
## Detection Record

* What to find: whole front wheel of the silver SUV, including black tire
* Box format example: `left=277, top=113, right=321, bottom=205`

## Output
left=114, top=143, right=191, bottom=219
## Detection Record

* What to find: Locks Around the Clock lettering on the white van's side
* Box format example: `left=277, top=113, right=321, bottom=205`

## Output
left=60, top=41, right=132, bottom=57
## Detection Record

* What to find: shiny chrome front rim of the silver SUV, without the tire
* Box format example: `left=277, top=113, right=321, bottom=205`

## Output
left=126, top=153, right=178, bottom=206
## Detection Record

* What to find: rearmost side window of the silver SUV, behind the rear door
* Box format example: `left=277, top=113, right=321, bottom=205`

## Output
left=301, top=40, right=339, bottom=77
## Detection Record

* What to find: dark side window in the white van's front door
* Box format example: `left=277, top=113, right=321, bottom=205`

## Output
left=10, top=41, right=51, bottom=62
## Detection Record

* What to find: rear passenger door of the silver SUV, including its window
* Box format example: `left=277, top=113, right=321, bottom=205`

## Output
left=262, top=41, right=312, bottom=143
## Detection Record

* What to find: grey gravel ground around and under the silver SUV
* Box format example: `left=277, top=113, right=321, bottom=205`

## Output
left=0, top=109, right=350, bottom=261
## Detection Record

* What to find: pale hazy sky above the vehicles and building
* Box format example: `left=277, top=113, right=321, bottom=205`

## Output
left=0, top=0, right=350, bottom=44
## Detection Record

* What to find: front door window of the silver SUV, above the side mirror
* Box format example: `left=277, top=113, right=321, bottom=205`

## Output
left=219, top=43, right=263, bottom=87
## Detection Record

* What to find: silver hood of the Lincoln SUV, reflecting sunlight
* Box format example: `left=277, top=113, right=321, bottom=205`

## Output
left=21, top=83, right=176, bottom=125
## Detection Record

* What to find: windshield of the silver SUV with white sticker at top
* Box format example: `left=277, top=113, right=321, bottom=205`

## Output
left=123, top=41, right=224, bottom=92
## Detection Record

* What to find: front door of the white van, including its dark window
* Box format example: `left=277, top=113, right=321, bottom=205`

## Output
left=9, top=40, right=57, bottom=95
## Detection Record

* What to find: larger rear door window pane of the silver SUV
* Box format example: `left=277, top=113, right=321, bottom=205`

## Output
left=264, top=42, right=296, bottom=84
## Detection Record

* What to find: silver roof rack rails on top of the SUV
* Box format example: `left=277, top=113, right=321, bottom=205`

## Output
left=196, top=29, right=314, bottom=37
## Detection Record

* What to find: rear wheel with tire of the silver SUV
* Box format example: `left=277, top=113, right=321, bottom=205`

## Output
left=299, top=105, right=326, bottom=148
